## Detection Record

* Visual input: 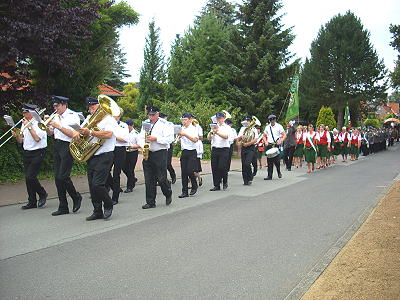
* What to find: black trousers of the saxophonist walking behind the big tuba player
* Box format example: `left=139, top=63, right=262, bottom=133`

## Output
left=143, top=149, right=172, bottom=205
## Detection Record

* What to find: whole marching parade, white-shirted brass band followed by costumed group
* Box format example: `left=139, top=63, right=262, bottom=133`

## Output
left=0, top=95, right=399, bottom=221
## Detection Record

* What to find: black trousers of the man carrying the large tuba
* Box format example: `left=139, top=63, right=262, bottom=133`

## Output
left=87, top=152, right=114, bottom=215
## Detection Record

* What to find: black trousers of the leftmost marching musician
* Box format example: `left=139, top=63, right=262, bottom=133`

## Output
left=23, top=148, right=46, bottom=204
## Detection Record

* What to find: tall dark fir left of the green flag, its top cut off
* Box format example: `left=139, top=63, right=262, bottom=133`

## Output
left=236, top=0, right=297, bottom=115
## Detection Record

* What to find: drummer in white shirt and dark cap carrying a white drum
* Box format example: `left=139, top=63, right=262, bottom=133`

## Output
left=264, top=115, right=286, bottom=180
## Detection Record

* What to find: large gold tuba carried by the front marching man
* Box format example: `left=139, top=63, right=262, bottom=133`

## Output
left=69, top=95, right=120, bottom=162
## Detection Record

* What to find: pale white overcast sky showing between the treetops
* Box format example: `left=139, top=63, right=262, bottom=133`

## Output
left=120, top=0, right=400, bottom=81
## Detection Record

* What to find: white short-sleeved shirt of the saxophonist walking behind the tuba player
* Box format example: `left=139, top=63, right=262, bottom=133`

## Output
left=138, top=118, right=174, bottom=152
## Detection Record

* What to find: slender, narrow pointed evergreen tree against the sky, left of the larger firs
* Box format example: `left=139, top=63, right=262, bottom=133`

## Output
left=139, top=20, right=166, bottom=109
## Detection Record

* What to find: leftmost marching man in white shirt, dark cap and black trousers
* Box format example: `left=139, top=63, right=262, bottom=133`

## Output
left=12, top=104, right=48, bottom=209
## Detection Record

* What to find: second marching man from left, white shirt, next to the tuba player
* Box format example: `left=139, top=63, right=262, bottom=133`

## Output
left=46, top=96, right=82, bottom=216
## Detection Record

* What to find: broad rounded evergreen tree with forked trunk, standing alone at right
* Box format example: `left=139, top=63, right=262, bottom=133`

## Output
left=300, top=11, right=387, bottom=127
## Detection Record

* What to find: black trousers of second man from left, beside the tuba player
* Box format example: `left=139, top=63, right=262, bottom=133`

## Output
left=54, top=140, right=79, bottom=211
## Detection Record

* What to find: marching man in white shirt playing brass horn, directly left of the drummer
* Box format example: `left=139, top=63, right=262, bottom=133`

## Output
left=236, top=115, right=258, bottom=185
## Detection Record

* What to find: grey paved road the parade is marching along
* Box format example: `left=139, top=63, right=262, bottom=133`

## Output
left=0, top=147, right=400, bottom=299
